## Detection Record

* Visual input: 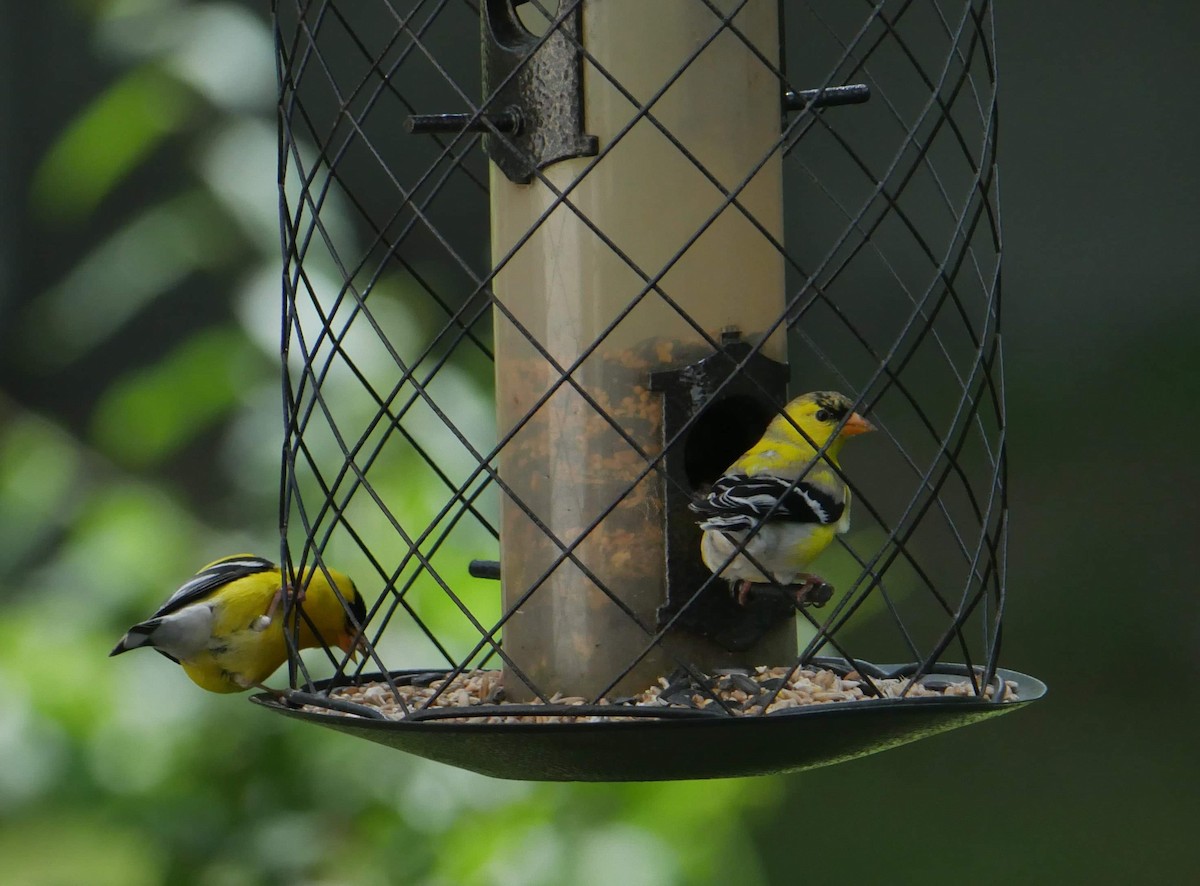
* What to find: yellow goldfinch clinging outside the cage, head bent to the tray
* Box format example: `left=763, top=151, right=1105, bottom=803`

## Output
left=109, top=553, right=366, bottom=693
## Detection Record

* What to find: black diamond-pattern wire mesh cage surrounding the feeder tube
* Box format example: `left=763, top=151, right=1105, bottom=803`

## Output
left=274, top=0, right=1007, bottom=715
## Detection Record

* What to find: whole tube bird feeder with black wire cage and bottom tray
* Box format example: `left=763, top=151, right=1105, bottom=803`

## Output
left=263, top=0, right=1044, bottom=778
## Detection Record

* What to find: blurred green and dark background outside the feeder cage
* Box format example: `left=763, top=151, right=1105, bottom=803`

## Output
left=0, top=0, right=1200, bottom=886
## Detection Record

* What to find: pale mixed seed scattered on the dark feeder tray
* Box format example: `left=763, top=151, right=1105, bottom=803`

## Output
left=295, top=666, right=1018, bottom=724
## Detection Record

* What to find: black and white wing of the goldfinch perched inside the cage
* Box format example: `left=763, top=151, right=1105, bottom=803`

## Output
left=690, top=474, right=846, bottom=532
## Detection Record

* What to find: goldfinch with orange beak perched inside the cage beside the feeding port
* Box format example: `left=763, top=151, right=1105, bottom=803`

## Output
left=691, top=391, right=875, bottom=605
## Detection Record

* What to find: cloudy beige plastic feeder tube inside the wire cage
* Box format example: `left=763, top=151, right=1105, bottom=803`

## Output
left=491, top=0, right=796, bottom=700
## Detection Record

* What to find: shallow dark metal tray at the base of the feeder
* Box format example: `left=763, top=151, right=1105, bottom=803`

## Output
left=252, top=659, right=1045, bottom=782
